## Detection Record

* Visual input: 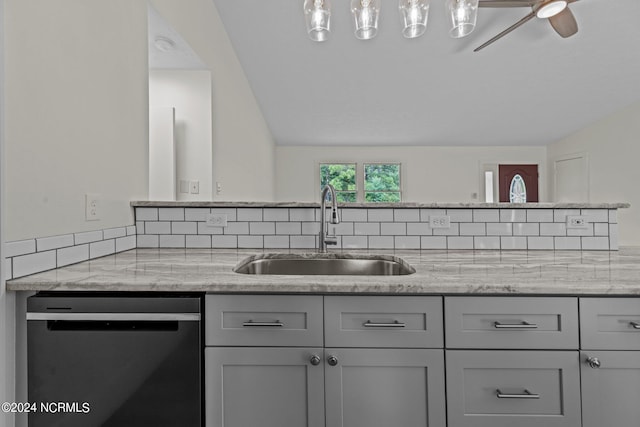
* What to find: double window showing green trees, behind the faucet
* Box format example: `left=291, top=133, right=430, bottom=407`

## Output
left=320, top=163, right=402, bottom=203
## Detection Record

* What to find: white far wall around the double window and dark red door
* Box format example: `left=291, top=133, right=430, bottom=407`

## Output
left=276, top=146, right=547, bottom=202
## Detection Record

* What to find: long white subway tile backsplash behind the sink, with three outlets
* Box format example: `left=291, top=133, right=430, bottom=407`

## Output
left=136, top=207, right=618, bottom=250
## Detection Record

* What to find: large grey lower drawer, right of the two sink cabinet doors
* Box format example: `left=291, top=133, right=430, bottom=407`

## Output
left=446, top=350, right=581, bottom=427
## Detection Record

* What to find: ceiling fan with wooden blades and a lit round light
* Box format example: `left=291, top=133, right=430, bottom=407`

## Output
left=473, top=0, right=578, bottom=52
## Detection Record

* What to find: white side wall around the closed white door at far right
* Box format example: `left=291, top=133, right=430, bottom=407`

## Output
left=547, top=103, right=640, bottom=246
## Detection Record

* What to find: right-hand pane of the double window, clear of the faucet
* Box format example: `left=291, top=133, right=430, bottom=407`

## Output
left=364, top=163, right=401, bottom=202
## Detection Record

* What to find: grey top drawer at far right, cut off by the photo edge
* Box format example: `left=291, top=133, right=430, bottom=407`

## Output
left=580, top=298, right=640, bottom=350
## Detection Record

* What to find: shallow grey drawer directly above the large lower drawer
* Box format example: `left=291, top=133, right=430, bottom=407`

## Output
left=444, top=297, right=578, bottom=349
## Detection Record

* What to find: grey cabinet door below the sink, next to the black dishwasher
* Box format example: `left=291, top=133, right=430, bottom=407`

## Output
left=205, top=347, right=324, bottom=427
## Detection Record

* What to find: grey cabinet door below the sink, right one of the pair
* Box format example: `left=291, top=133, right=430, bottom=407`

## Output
left=325, top=348, right=446, bottom=427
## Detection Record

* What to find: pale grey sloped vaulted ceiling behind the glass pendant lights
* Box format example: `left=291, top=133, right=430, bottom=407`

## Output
left=208, top=0, right=640, bottom=146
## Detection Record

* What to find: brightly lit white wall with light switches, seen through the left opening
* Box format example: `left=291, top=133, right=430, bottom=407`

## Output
left=149, top=70, right=213, bottom=201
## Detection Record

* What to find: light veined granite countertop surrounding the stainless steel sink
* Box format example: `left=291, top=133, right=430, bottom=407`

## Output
left=7, top=248, right=640, bottom=295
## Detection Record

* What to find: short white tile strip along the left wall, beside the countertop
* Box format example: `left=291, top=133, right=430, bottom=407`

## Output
left=3, top=225, right=136, bottom=280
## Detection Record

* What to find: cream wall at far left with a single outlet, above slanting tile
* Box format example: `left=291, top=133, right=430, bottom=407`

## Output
left=5, top=0, right=149, bottom=241
